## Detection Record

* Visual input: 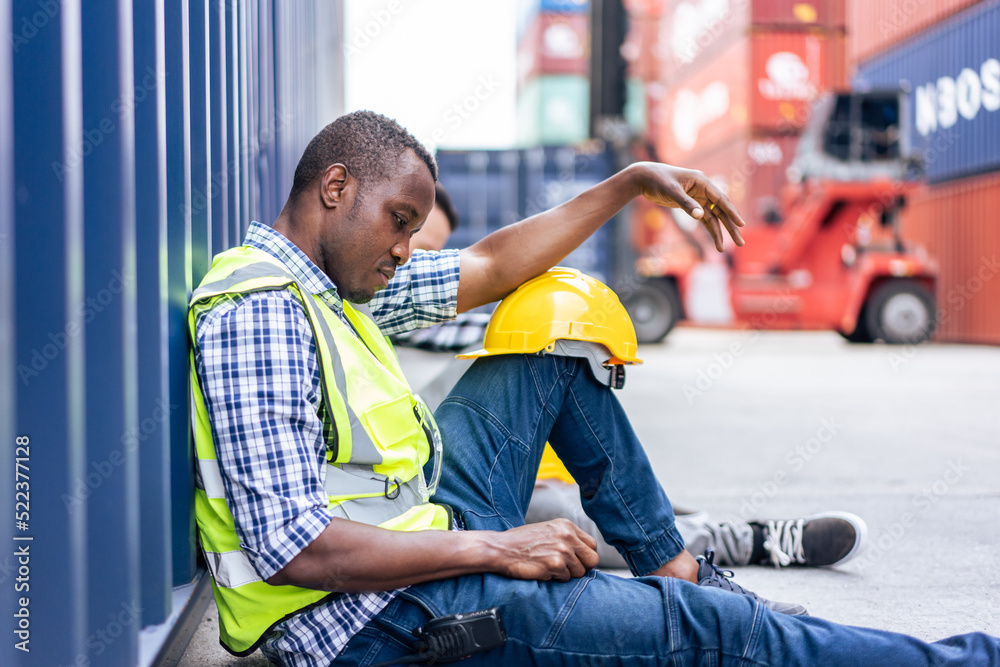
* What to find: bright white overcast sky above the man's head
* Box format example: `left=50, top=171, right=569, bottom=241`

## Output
left=344, top=0, right=516, bottom=149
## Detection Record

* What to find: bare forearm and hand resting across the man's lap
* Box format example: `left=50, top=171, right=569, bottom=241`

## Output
left=267, top=518, right=598, bottom=593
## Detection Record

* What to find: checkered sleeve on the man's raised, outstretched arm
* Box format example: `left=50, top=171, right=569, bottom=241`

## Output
left=369, top=250, right=459, bottom=334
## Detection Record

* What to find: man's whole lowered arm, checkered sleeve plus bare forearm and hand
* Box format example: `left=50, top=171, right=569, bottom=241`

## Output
left=196, top=292, right=598, bottom=592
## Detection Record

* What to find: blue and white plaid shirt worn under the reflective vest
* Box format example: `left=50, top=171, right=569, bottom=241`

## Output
left=195, top=222, right=458, bottom=667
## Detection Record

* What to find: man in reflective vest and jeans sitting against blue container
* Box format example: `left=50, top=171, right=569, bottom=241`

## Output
left=189, top=112, right=1000, bottom=665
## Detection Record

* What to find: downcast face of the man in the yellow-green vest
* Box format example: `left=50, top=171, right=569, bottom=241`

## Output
left=320, top=151, right=434, bottom=303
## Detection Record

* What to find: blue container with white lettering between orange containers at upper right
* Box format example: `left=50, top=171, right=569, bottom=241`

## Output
left=854, top=0, right=1000, bottom=183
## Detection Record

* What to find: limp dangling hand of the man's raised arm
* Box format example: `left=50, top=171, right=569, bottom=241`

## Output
left=629, top=162, right=745, bottom=252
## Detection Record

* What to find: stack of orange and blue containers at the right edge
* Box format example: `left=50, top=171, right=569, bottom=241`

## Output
left=850, top=0, right=1000, bottom=344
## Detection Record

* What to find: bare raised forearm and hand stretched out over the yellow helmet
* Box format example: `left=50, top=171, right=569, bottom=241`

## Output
left=458, top=162, right=744, bottom=313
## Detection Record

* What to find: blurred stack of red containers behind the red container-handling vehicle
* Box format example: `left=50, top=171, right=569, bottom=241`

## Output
left=626, top=0, right=847, bottom=272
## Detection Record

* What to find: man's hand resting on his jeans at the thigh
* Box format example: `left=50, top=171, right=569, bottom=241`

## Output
left=493, top=519, right=598, bottom=581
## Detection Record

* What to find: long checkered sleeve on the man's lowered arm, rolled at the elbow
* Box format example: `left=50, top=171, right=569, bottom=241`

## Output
left=195, top=291, right=331, bottom=579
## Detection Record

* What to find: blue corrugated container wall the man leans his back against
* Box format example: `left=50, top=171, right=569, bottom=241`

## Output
left=0, top=0, right=344, bottom=667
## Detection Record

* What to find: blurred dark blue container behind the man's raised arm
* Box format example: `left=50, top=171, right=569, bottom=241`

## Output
left=437, top=147, right=615, bottom=283
